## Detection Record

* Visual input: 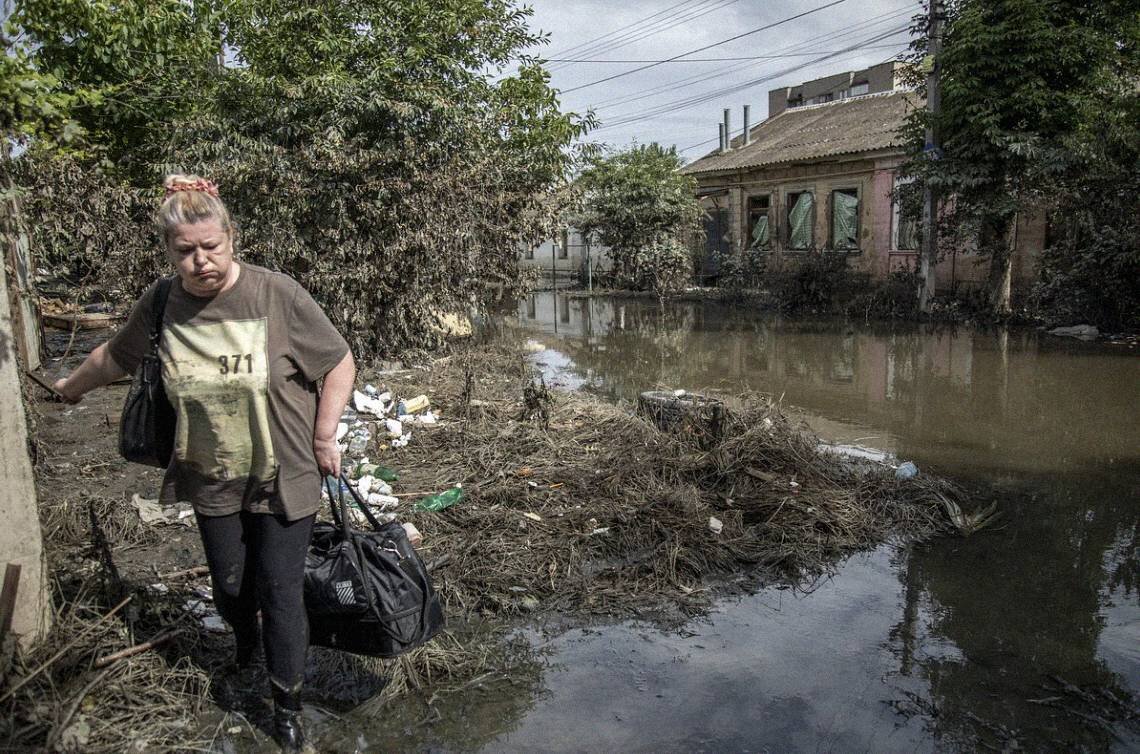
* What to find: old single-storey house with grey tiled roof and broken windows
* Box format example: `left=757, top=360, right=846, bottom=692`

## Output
left=683, top=62, right=1044, bottom=289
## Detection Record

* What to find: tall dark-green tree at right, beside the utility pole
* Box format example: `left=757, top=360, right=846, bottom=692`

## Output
left=906, top=0, right=1137, bottom=315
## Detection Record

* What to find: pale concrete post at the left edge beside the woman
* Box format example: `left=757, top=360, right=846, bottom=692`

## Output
left=0, top=253, right=51, bottom=646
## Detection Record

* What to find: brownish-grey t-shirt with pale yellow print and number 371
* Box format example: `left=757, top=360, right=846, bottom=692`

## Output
left=108, top=264, right=349, bottom=520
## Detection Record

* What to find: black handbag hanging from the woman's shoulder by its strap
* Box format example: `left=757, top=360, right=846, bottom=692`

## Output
left=119, top=277, right=177, bottom=469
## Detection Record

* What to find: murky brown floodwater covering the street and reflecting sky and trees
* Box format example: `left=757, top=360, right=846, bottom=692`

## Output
left=332, top=293, right=1140, bottom=752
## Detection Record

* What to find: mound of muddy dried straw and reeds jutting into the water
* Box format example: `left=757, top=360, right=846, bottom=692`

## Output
left=369, top=346, right=964, bottom=615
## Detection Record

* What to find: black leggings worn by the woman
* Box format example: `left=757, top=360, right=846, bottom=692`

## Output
left=197, top=511, right=316, bottom=691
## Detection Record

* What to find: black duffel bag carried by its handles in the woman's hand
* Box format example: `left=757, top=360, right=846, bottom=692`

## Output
left=304, top=475, right=443, bottom=657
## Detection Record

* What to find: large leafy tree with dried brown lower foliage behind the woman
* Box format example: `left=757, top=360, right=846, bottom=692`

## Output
left=8, top=0, right=591, bottom=355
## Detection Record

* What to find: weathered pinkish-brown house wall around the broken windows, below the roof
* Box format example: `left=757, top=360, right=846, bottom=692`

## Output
left=698, top=155, right=1045, bottom=290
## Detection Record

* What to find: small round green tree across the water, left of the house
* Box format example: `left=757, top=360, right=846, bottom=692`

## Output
left=576, top=144, right=701, bottom=292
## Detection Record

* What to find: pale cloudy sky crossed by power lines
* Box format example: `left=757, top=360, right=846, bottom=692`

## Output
left=513, top=0, right=921, bottom=160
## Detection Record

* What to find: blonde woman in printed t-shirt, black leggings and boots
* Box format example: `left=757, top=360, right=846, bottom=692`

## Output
left=55, top=176, right=356, bottom=751
